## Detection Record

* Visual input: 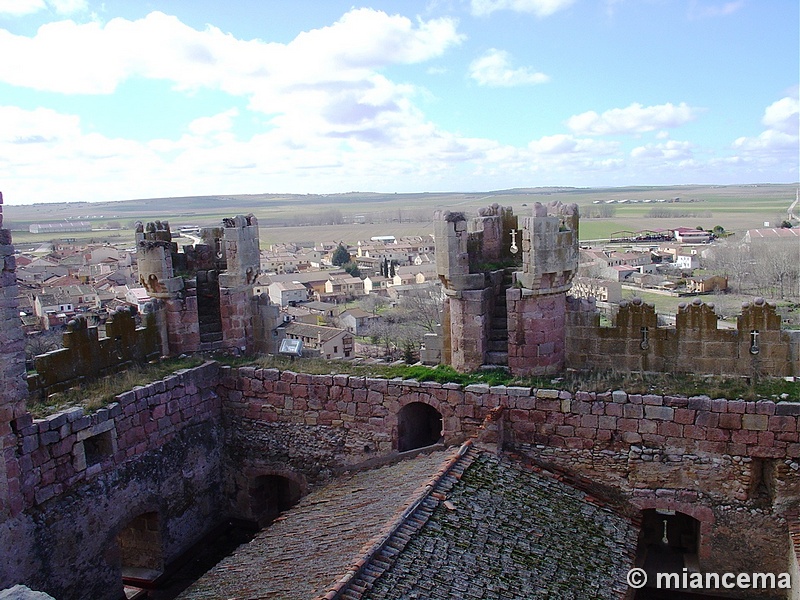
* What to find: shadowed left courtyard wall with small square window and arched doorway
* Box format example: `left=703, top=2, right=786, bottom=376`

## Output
left=0, top=363, right=228, bottom=600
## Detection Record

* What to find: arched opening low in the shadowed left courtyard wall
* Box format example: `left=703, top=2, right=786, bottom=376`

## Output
left=117, top=512, right=164, bottom=585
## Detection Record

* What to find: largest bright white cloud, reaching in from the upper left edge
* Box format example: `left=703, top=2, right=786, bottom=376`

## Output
left=0, top=9, right=463, bottom=178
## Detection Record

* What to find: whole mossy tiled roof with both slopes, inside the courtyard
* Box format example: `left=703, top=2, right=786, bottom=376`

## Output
left=179, top=445, right=638, bottom=600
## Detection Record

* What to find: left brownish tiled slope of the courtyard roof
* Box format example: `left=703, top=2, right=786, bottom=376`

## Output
left=179, top=449, right=457, bottom=600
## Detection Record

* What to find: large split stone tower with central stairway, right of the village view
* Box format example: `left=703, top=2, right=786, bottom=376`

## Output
left=434, top=202, right=579, bottom=375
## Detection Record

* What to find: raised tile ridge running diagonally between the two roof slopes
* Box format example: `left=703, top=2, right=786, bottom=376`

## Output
left=316, top=439, right=477, bottom=600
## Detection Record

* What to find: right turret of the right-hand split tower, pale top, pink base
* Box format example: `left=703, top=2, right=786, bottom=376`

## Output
left=506, top=202, right=579, bottom=375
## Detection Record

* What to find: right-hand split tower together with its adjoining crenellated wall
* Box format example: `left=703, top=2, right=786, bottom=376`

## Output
left=428, top=202, right=800, bottom=377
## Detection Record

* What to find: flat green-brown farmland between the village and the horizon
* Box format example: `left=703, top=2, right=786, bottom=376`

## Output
left=3, top=184, right=797, bottom=247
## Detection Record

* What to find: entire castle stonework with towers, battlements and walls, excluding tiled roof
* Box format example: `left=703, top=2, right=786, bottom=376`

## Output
left=0, top=195, right=800, bottom=600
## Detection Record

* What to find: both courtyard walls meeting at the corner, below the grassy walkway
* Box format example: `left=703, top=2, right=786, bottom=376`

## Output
left=0, top=363, right=800, bottom=600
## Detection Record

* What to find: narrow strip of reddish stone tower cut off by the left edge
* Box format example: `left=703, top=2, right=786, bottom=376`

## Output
left=0, top=192, right=28, bottom=522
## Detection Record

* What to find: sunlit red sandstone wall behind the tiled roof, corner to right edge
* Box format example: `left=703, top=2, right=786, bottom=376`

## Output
left=221, top=368, right=800, bottom=584
